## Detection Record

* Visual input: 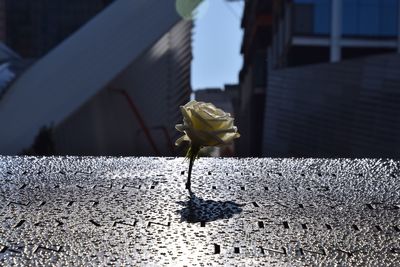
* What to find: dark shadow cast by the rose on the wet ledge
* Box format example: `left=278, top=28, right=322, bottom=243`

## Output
left=177, top=193, right=245, bottom=223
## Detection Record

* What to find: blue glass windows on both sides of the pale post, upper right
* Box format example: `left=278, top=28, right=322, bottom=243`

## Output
left=293, top=0, right=398, bottom=37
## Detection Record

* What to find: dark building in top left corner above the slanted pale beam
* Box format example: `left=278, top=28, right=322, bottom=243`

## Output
left=5, top=0, right=112, bottom=58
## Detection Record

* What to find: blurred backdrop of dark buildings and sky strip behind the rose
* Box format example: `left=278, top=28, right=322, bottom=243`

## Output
left=0, top=0, right=400, bottom=158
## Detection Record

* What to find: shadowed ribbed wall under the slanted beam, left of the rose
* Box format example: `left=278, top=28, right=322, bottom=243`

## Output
left=55, top=21, right=192, bottom=156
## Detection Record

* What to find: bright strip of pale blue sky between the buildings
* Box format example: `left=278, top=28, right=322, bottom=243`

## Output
left=191, top=0, right=244, bottom=90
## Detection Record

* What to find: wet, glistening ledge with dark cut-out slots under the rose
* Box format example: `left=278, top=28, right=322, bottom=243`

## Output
left=0, top=157, right=400, bottom=266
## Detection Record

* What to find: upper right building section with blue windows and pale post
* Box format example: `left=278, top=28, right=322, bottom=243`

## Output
left=268, top=0, right=400, bottom=69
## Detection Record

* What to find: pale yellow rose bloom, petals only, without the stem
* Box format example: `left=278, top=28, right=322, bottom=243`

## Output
left=175, top=100, right=240, bottom=147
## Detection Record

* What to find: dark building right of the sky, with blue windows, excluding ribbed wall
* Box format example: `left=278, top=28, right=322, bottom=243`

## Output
left=238, top=0, right=400, bottom=156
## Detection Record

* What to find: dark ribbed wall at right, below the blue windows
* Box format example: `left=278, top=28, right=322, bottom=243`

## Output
left=263, top=54, right=400, bottom=158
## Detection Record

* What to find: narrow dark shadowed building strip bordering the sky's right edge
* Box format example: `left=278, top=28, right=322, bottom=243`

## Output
left=237, top=0, right=273, bottom=156
